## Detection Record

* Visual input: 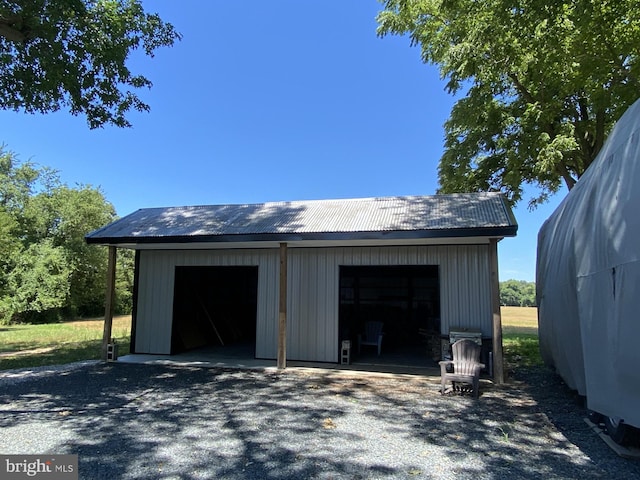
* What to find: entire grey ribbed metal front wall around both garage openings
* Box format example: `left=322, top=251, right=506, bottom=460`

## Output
left=136, top=245, right=492, bottom=362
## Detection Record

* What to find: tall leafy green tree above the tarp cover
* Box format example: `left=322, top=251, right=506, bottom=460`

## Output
left=377, top=0, right=640, bottom=206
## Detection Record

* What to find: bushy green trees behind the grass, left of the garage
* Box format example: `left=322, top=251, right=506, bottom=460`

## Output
left=0, top=149, right=133, bottom=323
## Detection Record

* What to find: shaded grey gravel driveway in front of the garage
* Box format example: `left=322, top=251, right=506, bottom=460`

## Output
left=0, top=362, right=640, bottom=479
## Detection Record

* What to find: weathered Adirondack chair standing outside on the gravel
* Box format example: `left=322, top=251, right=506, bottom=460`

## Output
left=439, top=339, right=484, bottom=398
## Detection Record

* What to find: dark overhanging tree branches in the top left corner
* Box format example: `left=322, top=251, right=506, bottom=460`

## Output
left=0, top=0, right=180, bottom=128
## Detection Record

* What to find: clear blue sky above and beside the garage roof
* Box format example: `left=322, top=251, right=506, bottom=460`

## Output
left=0, top=0, right=561, bottom=281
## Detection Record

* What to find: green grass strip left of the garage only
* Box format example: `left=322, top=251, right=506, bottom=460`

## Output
left=0, top=316, right=131, bottom=370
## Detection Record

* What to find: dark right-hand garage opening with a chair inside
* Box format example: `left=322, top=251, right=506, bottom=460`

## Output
left=340, top=265, right=440, bottom=364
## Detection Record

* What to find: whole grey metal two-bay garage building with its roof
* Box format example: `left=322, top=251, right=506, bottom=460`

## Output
left=86, top=193, right=517, bottom=376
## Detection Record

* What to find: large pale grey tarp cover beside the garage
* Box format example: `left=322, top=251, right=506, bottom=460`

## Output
left=536, top=100, right=640, bottom=427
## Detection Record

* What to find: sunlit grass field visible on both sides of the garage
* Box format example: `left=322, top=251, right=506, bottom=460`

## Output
left=0, top=307, right=542, bottom=370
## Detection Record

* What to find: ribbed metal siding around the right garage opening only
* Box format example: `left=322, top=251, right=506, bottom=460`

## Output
left=287, top=245, right=492, bottom=362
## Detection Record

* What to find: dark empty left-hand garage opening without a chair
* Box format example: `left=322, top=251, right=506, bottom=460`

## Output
left=171, top=266, right=258, bottom=357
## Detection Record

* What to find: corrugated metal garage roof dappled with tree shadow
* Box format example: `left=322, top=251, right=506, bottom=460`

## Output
left=86, top=193, right=518, bottom=245
